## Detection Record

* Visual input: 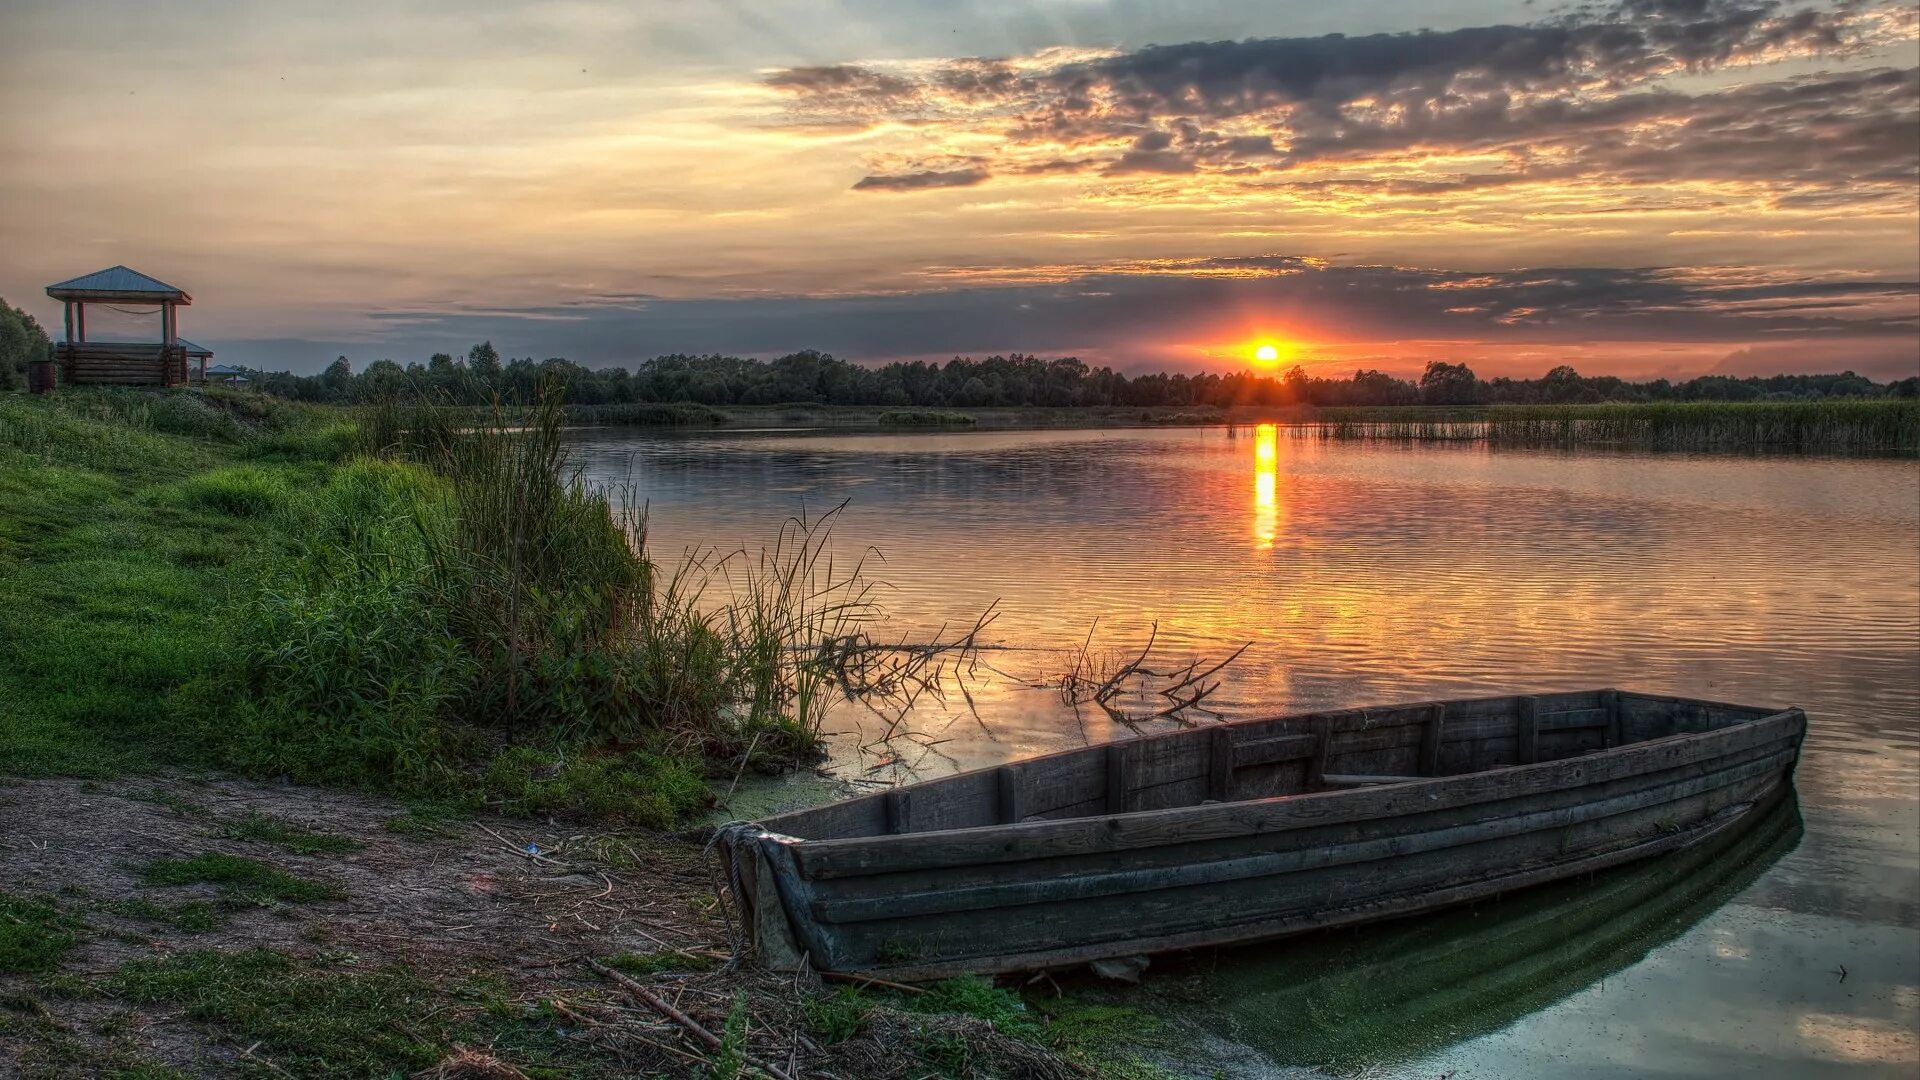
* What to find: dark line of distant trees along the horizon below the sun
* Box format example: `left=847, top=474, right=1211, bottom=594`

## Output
left=248, top=342, right=1920, bottom=407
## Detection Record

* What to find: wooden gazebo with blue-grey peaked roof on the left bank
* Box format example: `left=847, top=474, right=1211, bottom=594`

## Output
left=46, top=267, right=194, bottom=386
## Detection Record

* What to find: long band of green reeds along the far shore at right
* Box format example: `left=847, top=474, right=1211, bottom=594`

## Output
left=1294, top=400, right=1920, bottom=454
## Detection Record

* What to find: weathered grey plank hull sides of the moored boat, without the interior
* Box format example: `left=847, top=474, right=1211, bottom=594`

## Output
left=726, top=692, right=1807, bottom=980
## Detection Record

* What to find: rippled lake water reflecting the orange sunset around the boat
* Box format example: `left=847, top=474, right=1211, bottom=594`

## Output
left=578, top=429, right=1920, bottom=1076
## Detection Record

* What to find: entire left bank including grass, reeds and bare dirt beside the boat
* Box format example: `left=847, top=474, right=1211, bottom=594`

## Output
left=0, top=390, right=1165, bottom=1080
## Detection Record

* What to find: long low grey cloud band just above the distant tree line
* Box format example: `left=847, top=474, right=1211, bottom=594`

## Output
left=228, top=256, right=1920, bottom=369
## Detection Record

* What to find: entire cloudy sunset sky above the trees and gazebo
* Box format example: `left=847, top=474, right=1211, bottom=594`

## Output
left=0, top=0, right=1920, bottom=379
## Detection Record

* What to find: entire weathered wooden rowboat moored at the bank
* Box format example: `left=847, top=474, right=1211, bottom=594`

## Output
left=720, top=690, right=1807, bottom=980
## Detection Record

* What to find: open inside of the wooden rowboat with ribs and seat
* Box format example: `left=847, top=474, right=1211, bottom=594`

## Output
left=762, top=690, right=1776, bottom=840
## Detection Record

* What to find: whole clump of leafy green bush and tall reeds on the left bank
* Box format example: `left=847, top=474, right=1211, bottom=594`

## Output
left=232, top=386, right=874, bottom=824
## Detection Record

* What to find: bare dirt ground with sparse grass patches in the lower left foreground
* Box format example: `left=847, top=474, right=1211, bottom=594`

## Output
left=0, top=778, right=1092, bottom=1080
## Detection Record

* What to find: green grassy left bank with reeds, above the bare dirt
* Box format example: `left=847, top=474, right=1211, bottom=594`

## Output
left=0, top=390, right=862, bottom=826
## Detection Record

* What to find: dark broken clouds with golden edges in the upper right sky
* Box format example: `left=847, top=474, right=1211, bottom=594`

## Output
left=764, top=0, right=1920, bottom=206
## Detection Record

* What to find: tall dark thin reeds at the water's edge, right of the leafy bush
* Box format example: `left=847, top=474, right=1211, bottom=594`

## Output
left=341, top=390, right=876, bottom=761
